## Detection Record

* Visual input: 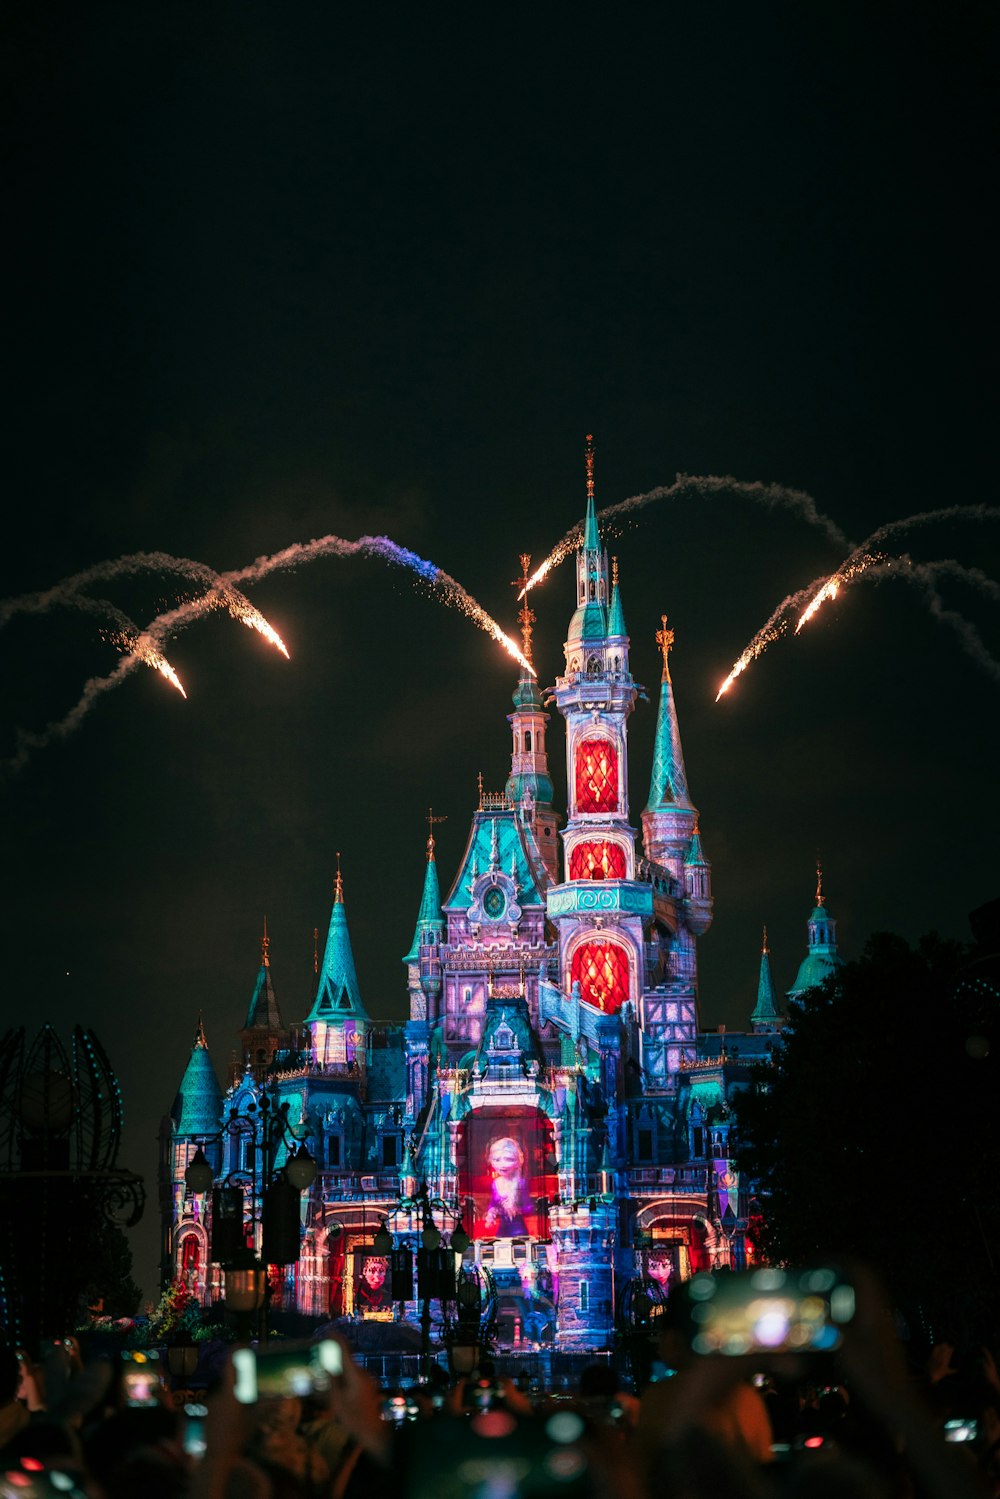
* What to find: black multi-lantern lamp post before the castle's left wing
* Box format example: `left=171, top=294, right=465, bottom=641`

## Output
left=184, top=1090, right=316, bottom=1342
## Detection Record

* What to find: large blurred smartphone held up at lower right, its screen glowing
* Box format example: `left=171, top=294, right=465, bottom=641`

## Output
left=685, top=1265, right=855, bottom=1355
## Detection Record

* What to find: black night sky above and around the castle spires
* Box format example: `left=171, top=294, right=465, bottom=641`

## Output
left=0, top=0, right=1000, bottom=1294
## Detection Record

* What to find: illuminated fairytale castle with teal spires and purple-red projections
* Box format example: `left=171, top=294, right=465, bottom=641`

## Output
left=160, top=445, right=841, bottom=1349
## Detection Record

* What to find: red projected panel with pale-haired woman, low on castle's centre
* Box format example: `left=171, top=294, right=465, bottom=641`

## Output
left=459, top=1108, right=558, bottom=1240
